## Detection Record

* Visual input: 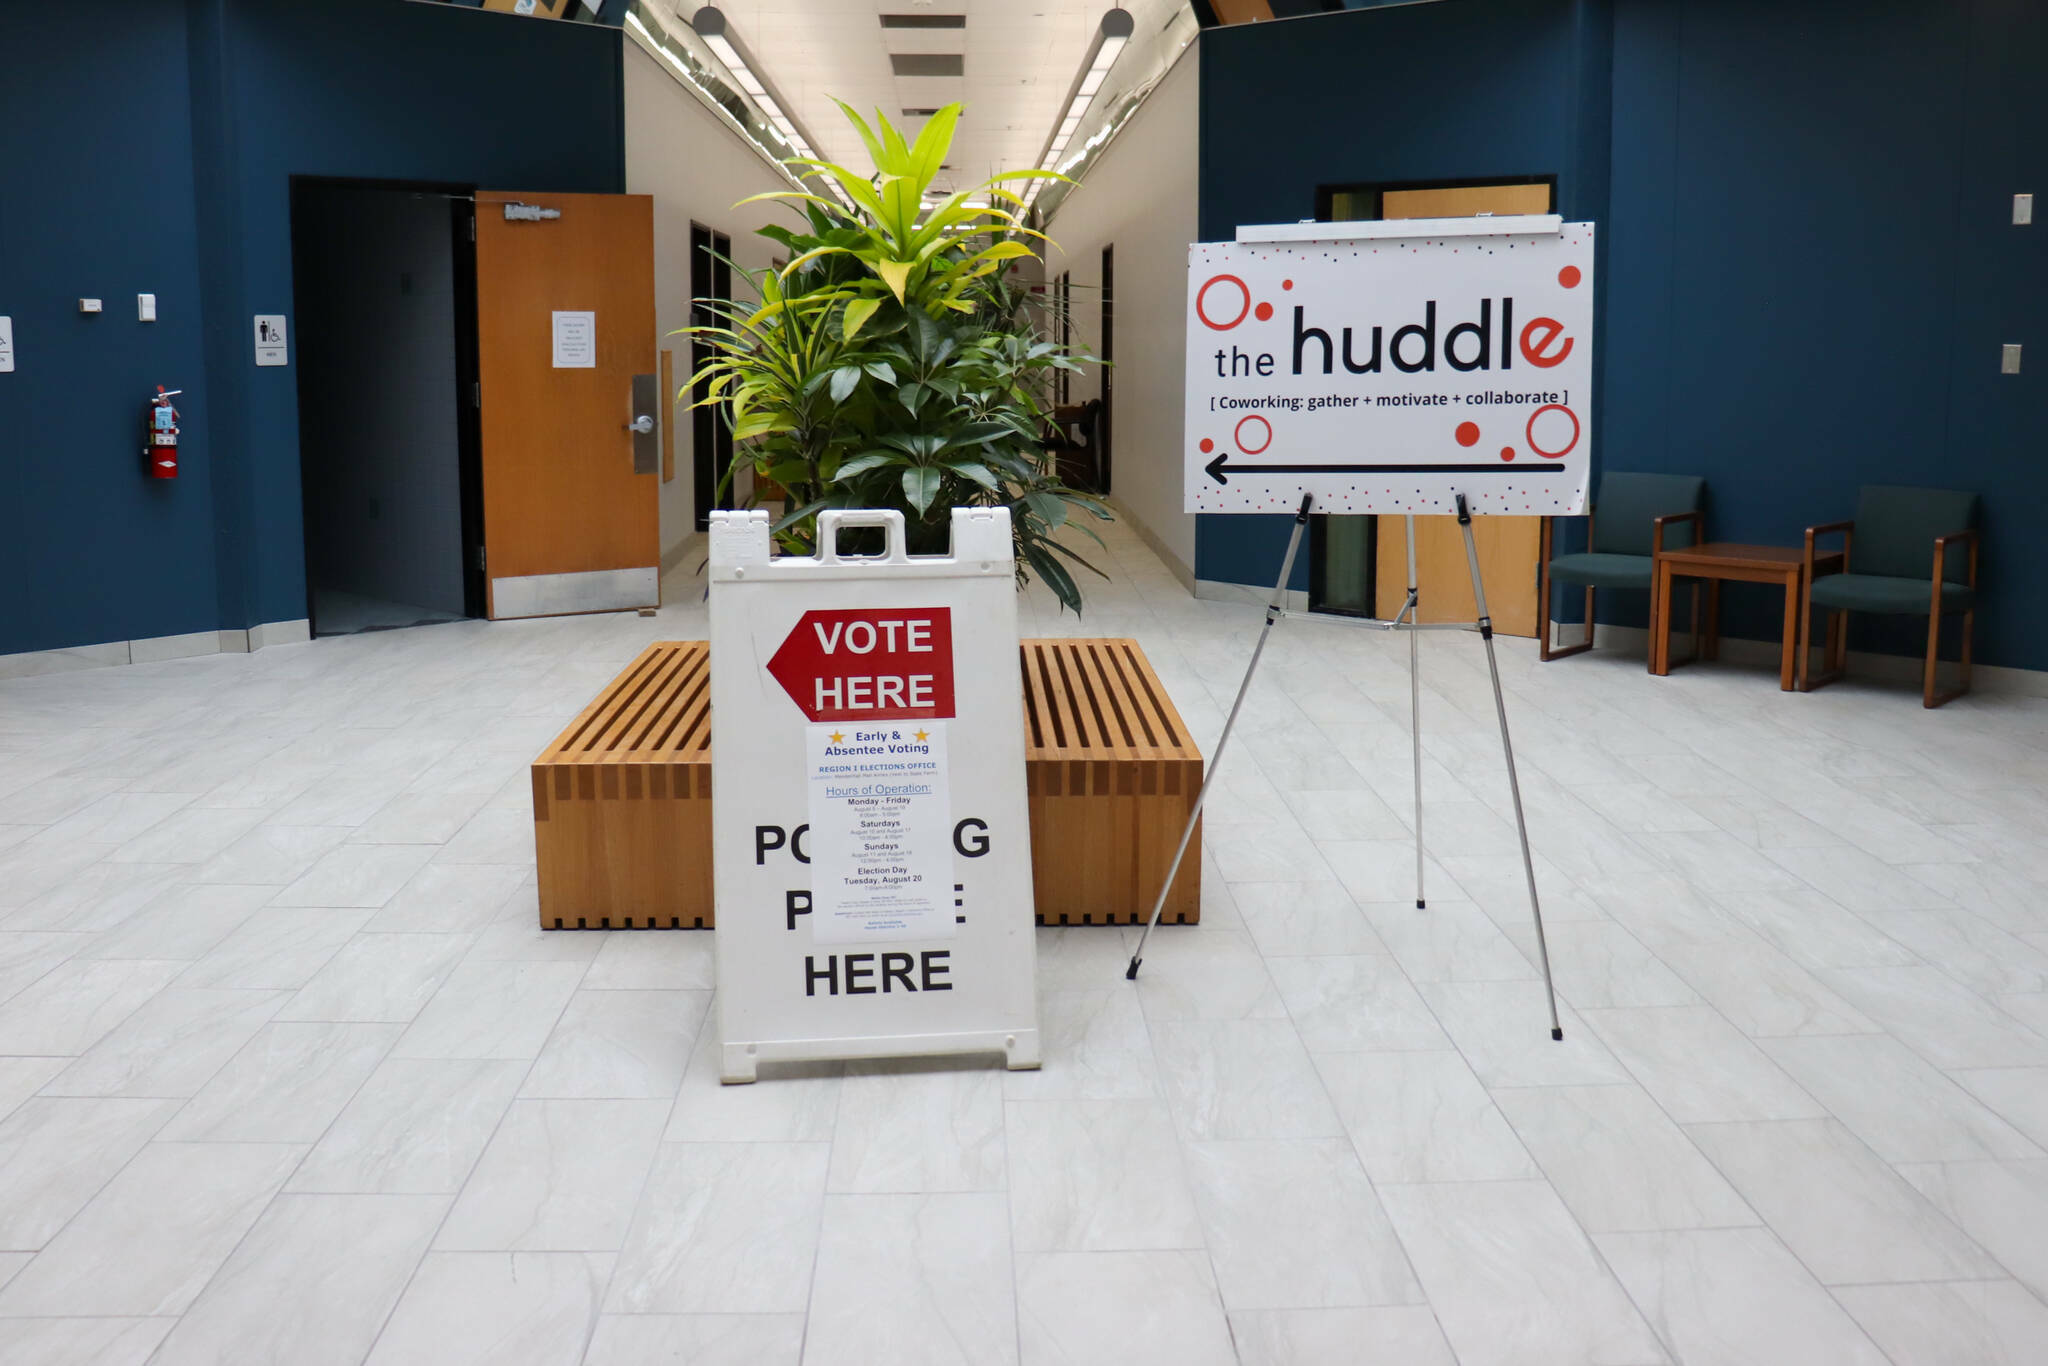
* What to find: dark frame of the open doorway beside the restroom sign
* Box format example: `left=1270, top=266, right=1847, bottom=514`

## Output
left=287, top=176, right=487, bottom=635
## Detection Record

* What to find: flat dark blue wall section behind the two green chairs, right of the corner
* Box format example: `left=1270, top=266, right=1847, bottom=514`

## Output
left=1602, top=0, right=2048, bottom=668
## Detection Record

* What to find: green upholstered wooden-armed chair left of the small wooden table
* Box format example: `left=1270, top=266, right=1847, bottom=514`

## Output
left=1536, top=471, right=1706, bottom=659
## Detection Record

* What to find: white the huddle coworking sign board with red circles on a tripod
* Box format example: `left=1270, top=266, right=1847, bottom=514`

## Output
left=1184, top=213, right=1593, bottom=516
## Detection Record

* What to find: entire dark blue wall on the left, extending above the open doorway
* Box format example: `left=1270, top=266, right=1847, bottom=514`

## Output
left=0, top=0, right=625, bottom=653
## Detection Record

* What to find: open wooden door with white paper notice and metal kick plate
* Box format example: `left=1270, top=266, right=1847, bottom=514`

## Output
left=477, top=190, right=662, bottom=618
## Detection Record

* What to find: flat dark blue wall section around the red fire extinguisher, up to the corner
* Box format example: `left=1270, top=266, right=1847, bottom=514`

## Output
left=0, top=4, right=221, bottom=653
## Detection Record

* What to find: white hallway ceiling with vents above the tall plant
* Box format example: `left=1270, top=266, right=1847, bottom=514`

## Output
left=676, top=0, right=1188, bottom=190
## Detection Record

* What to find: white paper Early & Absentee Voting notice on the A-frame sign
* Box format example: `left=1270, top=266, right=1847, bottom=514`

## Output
left=805, top=721, right=956, bottom=944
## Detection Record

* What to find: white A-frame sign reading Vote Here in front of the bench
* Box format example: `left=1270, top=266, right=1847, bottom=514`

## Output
left=711, top=508, right=1038, bottom=1081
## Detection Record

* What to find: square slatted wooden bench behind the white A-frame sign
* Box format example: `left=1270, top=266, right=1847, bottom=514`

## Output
left=532, top=639, right=1202, bottom=930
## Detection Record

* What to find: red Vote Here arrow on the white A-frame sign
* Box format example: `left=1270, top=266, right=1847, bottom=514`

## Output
left=768, top=606, right=952, bottom=721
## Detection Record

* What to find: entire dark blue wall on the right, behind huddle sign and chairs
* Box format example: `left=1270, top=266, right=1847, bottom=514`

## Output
left=1196, top=0, right=2048, bottom=668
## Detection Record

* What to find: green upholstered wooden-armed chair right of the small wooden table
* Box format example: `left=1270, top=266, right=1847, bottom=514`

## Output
left=1798, top=483, right=1976, bottom=707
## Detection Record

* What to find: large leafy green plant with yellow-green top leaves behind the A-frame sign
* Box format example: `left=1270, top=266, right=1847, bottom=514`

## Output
left=686, top=104, right=1110, bottom=612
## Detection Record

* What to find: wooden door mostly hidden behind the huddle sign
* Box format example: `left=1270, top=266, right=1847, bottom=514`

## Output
left=1372, top=184, right=1550, bottom=637
